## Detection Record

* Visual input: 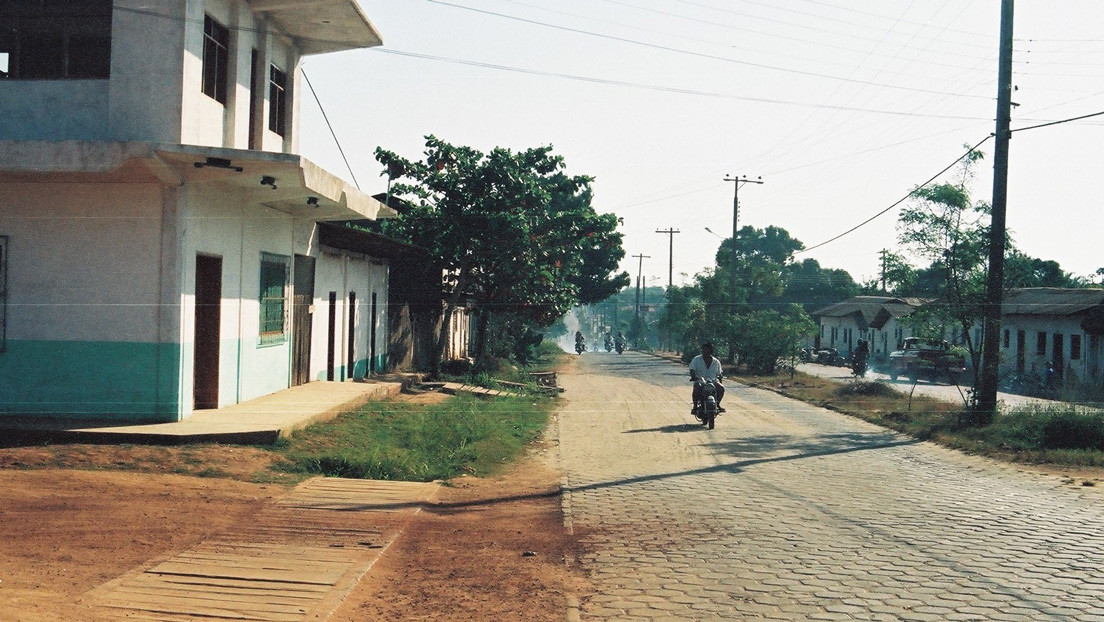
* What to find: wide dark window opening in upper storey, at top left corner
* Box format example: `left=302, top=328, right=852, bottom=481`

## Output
left=0, top=0, right=112, bottom=80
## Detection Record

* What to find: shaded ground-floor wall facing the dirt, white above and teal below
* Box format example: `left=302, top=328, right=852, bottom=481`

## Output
left=0, top=183, right=180, bottom=421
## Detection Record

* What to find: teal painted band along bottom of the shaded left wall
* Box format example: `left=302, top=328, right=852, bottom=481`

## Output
left=0, top=340, right=181, bottom=421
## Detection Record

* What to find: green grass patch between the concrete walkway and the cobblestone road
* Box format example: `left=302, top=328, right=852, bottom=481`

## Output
left=275, top=396, right=553, bottom=482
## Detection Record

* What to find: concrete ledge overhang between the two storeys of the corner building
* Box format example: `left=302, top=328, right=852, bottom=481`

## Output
left=0, top=141, right=399, bottom=221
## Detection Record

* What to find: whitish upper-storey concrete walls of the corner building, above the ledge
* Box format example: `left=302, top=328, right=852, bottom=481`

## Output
left=0, top=0, right=300, bottom=152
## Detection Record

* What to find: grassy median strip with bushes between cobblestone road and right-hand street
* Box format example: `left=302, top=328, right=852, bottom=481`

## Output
left=735, top=372, right=1104, bottom=466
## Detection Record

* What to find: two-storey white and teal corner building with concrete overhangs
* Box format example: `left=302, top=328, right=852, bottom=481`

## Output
left=0, top=0, right=393, bottom=421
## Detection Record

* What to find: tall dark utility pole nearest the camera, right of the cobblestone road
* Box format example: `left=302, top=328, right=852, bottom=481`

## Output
left=975, top=0, right=1015, bottom=425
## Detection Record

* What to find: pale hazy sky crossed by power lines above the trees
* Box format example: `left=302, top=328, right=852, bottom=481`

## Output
left=300, top=0, right=1104, bottom=285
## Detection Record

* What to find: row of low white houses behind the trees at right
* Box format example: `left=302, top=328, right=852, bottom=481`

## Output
left=810, top=287, right=1104, bottom=384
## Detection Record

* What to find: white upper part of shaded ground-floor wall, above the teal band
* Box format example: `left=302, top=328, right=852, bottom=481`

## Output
left=0, top=183, right=162, bottom=342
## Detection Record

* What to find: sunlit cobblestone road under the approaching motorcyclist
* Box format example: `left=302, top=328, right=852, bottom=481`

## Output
left=559, top=352, right=1104, bottom=621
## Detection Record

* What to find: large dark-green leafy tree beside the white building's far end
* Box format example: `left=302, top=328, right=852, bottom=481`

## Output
left=375, top=136, right=628, bottom=369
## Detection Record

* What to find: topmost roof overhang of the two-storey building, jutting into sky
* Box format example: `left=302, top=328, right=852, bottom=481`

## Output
left=248, top=0, right=383, bottom=55
